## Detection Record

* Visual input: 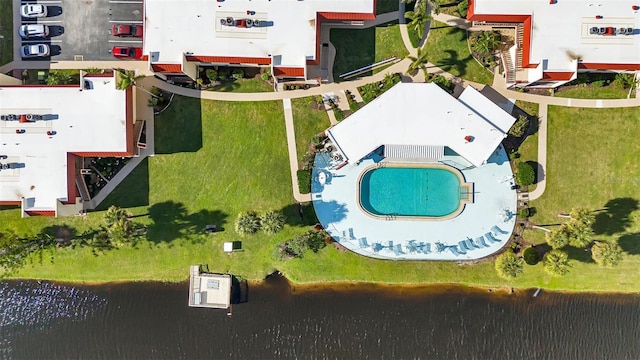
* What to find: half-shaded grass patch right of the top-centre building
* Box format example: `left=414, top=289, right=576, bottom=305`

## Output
left=331, top=21, right=409, bottom=81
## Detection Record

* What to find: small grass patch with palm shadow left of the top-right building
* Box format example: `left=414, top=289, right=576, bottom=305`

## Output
left=426, top=21, right=493, bottom=84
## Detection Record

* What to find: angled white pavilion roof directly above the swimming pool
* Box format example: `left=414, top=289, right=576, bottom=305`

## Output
left=327, top=83, right=515, bottom=166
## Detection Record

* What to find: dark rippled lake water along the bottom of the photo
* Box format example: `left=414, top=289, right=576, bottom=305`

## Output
left=0, top=277, right=640, bottom=359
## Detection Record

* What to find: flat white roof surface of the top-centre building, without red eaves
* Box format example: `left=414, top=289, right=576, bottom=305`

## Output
left=144, top=0, right=374, bottom=67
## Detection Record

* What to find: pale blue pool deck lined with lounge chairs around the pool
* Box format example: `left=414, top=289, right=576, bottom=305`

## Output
left=311, top=146, right=517, bottom=260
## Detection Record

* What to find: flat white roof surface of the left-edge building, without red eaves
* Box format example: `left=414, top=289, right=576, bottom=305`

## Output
left=0, top=77, right=127, bottom=211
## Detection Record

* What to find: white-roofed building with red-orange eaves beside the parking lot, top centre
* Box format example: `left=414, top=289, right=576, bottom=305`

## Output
left=143, top=0, right=375, bottom=79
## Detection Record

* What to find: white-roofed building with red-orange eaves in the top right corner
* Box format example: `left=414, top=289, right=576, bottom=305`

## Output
left=467, top=0, right=640, bottom=87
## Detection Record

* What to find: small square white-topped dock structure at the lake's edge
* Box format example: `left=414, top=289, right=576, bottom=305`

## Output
left=189, top=265, right=232, bottom=309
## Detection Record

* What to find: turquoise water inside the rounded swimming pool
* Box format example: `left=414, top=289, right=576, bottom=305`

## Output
left=360, top=167, right=460, bottom=217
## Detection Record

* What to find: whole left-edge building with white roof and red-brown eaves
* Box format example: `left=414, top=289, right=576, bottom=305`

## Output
left=0, top=74, right=146, bottom=216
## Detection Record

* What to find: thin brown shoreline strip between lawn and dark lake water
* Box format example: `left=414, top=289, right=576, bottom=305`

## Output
left=7, top=273, right=640, bottom=297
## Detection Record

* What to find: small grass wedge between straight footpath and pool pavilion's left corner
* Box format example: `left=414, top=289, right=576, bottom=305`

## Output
left=291, top=96, right=331, bottom=167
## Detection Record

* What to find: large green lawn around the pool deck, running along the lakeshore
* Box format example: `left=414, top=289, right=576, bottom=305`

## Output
left=10, top=97, right=640, bottom=292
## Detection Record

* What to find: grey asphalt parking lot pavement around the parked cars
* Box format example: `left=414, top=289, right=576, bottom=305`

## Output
left=21, top=0, right=143, bottom=61
